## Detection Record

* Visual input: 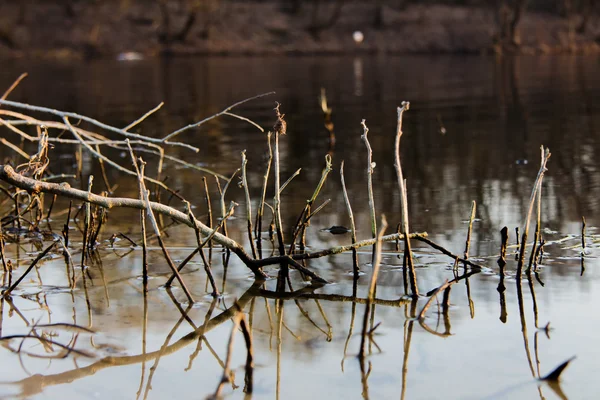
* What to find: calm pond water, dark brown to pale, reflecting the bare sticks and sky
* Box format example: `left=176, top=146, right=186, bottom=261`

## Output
left=0, top=56, right=600, bottom=399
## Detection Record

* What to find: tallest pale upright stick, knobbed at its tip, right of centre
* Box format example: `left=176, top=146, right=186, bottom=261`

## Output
left=394, top=101, right=419, bottom=296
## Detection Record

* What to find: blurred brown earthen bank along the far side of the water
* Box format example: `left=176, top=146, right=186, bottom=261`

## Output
left=0, top=0, right=600, bottom=57
